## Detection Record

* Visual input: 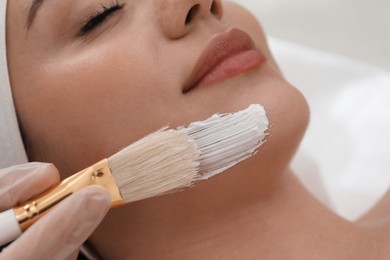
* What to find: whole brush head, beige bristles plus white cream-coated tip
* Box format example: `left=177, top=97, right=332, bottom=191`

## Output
left=108, top=105, right=269, bottom=203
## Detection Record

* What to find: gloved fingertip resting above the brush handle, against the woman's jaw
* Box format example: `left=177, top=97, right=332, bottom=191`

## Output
left=0, top=163, right=59, bottom=211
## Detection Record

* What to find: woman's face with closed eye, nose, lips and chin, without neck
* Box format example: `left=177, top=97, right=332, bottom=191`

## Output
left=7, top=0, right=308, bottom=178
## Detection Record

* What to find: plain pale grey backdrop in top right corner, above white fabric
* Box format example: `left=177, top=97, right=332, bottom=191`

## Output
left=236, top=0, right=390, bottom=72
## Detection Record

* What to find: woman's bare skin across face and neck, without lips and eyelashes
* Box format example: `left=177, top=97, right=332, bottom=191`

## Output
left=3, top=0, right=390, bottom=259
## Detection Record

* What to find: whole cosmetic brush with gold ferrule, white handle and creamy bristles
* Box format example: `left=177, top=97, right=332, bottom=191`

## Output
left=0, top=105, right=268, bottom=245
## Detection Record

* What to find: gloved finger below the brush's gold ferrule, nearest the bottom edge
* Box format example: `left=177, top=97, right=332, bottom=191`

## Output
left=2, top=186, right=111, bottom=259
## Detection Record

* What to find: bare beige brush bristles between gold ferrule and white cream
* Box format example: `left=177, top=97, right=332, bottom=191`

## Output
left=108, top=130, right=199, bottom=203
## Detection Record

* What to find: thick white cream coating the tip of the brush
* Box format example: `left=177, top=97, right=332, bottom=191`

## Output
left=177, top=104, right=269, bottom=180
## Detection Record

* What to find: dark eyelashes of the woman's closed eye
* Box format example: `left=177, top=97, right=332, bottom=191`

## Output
left=79, top=1, right=124, bottom=36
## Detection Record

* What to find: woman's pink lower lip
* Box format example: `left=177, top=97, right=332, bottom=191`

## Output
left=197, top=50, right=266, bottom=88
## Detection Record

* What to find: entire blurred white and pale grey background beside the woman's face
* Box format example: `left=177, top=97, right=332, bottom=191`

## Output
left=230, top=0, right=390, bottom=220
